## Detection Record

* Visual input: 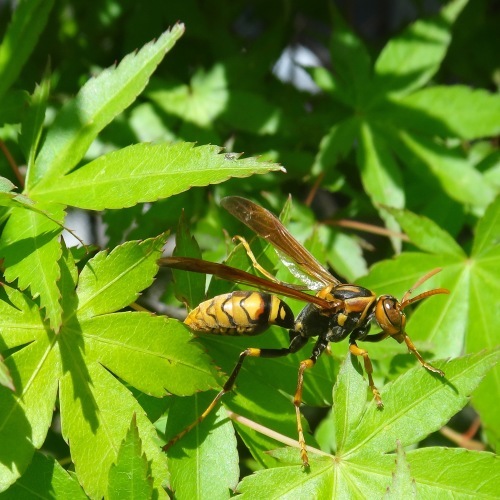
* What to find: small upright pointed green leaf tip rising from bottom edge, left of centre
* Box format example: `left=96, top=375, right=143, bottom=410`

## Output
left=107, top=415, right=153, bottom=500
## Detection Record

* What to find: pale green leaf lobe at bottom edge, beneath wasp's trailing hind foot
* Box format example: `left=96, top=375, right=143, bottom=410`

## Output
left=167, top=394, right=239, bottom=499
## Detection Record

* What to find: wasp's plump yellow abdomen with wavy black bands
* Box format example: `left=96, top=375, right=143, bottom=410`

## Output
left=184, top=291, right=294, bottom=335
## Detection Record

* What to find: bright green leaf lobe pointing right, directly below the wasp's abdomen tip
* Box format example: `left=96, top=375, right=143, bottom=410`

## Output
left=80, top=312, right=216, bottom=397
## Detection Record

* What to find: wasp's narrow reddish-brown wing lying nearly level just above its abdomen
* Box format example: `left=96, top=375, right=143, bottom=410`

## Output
left=157, top=257, right=341, bottom=309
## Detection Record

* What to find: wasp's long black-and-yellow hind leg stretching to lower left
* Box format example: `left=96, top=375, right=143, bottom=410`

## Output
left=163, top=335, right=308, bottom=451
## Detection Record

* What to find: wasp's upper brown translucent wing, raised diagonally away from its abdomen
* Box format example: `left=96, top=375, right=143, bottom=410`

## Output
left=221, top=196, right=340, bottom=285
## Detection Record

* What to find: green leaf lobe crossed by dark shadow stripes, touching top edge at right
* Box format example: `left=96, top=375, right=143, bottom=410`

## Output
left=374, top=0, right=467, bottom=95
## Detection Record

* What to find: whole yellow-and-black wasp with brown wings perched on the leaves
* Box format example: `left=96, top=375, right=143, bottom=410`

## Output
left=158, top=196, right=449, bottom=468
